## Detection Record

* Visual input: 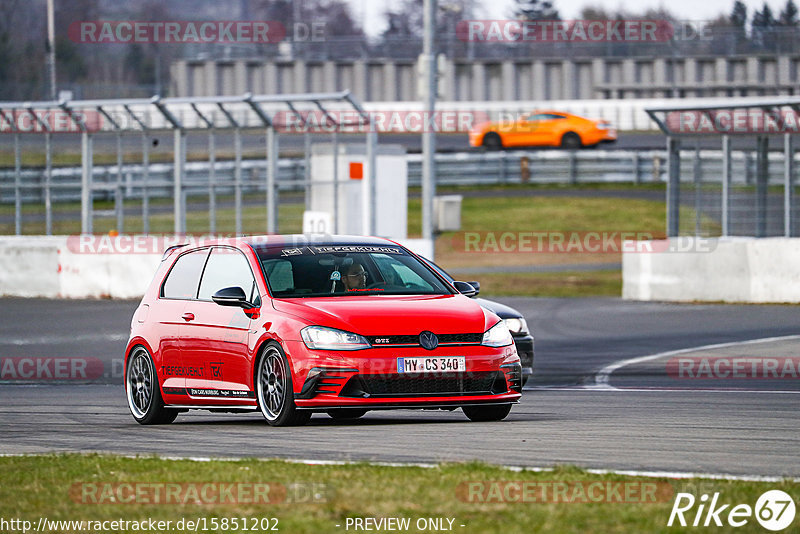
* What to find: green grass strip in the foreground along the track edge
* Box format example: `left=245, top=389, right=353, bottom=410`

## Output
left=0, top=454, right=800, bottom=534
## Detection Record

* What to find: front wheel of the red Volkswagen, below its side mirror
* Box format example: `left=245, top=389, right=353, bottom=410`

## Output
left=253, top=342, right=311, bottom=426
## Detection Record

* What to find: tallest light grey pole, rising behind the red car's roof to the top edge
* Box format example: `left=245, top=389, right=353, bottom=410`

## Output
left=422, top=0, right=436, bottom=247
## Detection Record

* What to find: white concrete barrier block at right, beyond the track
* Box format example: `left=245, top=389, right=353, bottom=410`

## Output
left=622, top=237, right=800, bottom=303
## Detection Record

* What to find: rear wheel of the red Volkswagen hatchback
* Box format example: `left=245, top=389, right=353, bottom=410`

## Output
left=125, top=345, right=178, bottom=425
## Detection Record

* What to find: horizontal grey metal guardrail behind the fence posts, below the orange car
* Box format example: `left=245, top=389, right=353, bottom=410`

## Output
left=0, top=150, right=796, bottom=236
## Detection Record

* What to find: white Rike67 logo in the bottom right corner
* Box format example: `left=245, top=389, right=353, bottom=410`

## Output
left=667, top=490, right=795, bottom=532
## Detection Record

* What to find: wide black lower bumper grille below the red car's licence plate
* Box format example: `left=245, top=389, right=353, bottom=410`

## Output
left=340, top=371, right=506, bottom=397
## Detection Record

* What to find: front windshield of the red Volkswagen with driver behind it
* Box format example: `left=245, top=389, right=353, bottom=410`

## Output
left=256, top=245, right=453, bottom=298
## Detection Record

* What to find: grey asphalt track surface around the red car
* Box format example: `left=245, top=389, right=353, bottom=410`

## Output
left=0, top=298, right=800, bottom=477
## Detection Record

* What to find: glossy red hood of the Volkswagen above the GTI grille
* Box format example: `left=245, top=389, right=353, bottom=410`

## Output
left=272, top=295, right=498, bottom=336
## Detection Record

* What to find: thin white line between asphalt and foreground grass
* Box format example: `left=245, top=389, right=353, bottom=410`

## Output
left=0, top=452, right=800, bottom=482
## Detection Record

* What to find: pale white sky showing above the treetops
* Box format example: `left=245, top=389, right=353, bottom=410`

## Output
left=347, top=0, right=786, bottom=35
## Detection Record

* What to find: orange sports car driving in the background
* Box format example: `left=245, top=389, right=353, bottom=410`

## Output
left=469, top=110, right=617, bottom=150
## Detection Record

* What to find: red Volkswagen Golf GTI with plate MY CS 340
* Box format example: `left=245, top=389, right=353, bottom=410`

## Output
left=125, top=236, right=521, bottom=426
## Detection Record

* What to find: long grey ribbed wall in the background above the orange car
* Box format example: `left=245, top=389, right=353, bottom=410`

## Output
left=171, top=52, right=800, bottom=102
